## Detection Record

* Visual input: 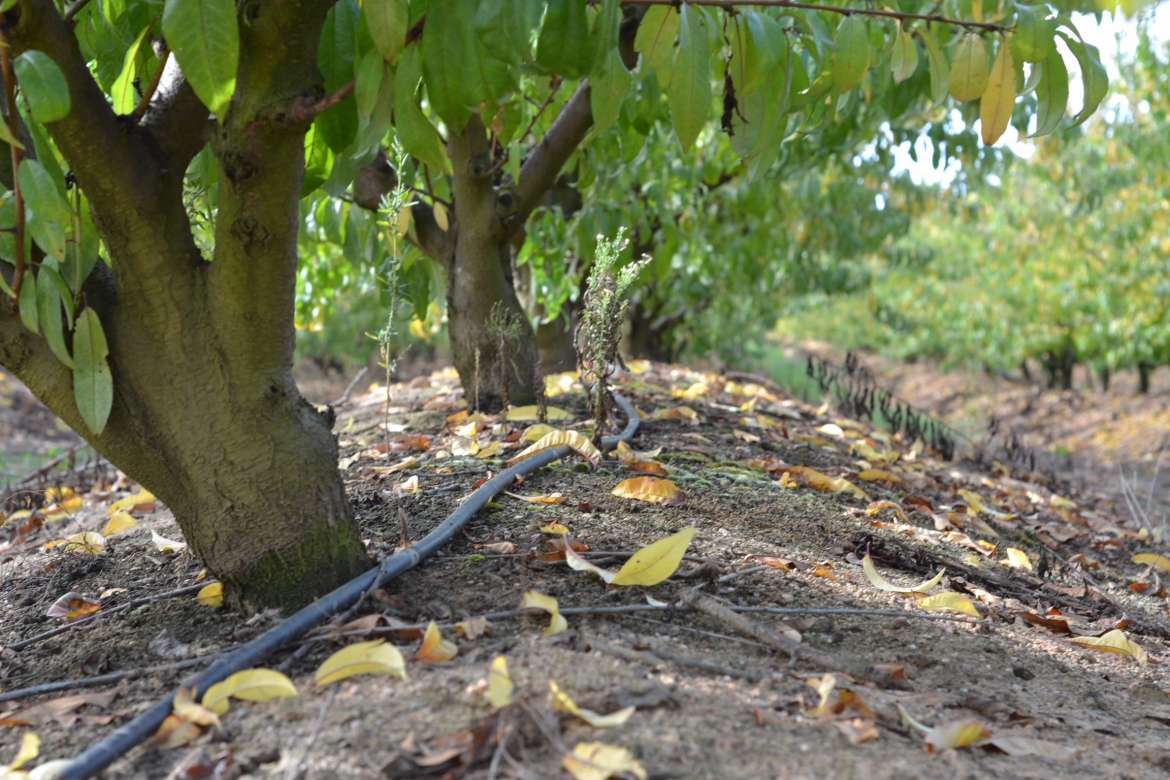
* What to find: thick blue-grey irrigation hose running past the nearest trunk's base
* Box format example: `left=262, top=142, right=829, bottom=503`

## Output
left=57, top=393, right=641, bottom=780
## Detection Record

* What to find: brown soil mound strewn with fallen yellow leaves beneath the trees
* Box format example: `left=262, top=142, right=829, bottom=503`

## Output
left=0, top=365, right=1170, bottom=779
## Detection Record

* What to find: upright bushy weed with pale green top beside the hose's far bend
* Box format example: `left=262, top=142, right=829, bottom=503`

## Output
left=576, top=227, right=649, bottom=444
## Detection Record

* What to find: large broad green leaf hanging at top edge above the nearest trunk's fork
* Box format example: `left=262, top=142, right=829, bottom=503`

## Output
left=163, top=0, right=240, bottom=122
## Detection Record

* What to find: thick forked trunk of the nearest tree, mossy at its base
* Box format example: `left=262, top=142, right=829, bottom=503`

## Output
left=0, top=0, right=369, bottom=608
